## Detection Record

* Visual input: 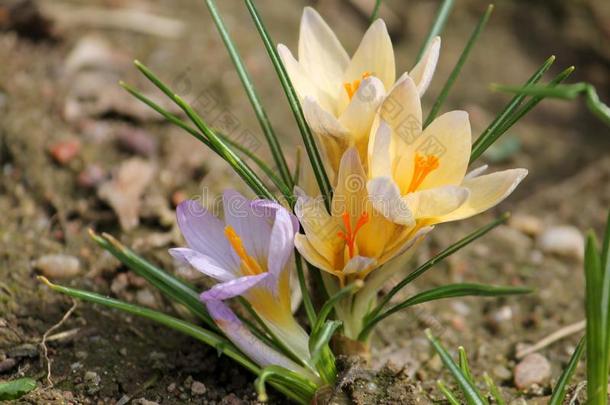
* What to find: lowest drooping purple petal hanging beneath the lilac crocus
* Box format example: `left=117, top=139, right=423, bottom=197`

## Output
left=205, top=300, right=307, bottom=374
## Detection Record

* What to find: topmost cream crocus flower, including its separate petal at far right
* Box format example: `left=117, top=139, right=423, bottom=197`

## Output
left=278, top=7, right=440, bottom=173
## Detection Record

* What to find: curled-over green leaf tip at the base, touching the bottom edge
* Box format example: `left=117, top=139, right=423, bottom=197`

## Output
left=254, top=365, right=317, bottom=404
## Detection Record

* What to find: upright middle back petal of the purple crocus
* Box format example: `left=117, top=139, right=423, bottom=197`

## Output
left=222, top=190, right=271, bottom=264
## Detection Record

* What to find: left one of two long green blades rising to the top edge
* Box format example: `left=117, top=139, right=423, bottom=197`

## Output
left=205, top=0, right=294, bottom=189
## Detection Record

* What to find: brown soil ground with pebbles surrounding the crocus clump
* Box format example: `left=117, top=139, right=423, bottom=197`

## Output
left=0, top=0, right=610, bottom=404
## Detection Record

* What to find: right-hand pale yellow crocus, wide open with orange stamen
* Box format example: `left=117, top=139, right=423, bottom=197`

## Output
left=367, top=77, right=527, bottom=227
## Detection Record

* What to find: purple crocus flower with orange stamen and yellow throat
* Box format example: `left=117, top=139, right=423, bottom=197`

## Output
left=170, top=191, right=309, bottom=369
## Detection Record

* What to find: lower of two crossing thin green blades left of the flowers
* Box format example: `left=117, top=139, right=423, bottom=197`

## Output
left=119, top=82, right=294, bottom=205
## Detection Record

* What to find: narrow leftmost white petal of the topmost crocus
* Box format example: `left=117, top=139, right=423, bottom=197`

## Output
left=277, top=44, right=336, bottom=113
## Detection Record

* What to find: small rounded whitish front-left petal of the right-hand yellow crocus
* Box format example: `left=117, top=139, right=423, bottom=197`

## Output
left=367, top=177, right=415, bottom=226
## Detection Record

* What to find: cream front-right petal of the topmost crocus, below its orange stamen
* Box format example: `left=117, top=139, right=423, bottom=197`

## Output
left=339, top=76, right=385, bottom=140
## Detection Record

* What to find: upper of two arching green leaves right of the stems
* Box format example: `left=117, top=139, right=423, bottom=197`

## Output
left=358, top=213, right=510, bottom=340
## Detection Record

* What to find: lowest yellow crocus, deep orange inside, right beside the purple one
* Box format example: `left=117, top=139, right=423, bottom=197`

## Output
left=295, top=148, right=430, bottom=284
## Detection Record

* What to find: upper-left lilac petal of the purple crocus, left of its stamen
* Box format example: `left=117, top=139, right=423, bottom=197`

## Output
left=176, top=200, right=239, bottom=269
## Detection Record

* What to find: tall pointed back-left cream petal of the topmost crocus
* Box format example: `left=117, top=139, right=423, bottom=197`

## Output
left=299, top=7, right=349, bottom=96
